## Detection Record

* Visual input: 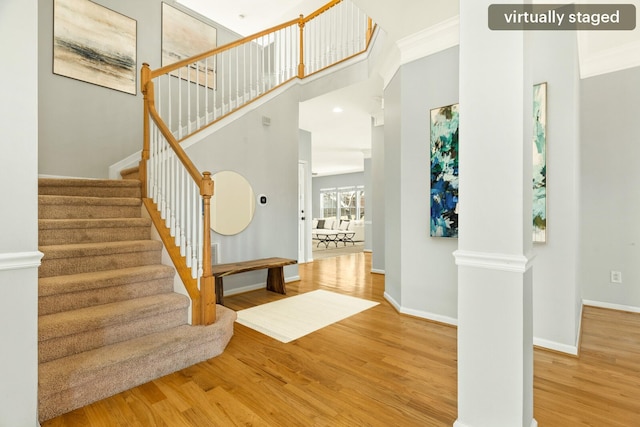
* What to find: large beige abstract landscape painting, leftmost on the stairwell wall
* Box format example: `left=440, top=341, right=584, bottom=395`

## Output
left=53, top=0, right=138, bottom=95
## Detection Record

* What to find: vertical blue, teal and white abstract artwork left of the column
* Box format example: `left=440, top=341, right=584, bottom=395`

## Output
left=430, top=104, right=459, bottom=237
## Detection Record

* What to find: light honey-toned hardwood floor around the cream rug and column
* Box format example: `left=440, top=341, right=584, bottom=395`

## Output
left=42, top=253, right=640, bottom=427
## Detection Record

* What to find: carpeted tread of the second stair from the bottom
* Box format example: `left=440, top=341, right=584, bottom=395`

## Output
left=38, top=292, right=189, bottom=342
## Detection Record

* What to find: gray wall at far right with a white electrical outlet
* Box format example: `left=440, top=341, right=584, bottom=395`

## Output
left=580, top=67, right=640, bottom=310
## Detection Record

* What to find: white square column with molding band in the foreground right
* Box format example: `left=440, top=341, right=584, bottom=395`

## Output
left=454, top=0, right=537, bottom=427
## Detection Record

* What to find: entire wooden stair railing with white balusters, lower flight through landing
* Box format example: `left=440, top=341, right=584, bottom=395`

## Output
left=140, top=0, right=373, bottom=325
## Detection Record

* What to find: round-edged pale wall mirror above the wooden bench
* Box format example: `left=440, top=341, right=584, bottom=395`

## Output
left=211, top=171, right=256, bottom=236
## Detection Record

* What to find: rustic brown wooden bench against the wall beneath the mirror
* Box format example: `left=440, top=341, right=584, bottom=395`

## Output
left=211, top=258, right=298, bottom=304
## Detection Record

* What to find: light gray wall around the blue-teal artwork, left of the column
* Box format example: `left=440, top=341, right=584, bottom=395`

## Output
left=384, top=47, right=458, bottom=321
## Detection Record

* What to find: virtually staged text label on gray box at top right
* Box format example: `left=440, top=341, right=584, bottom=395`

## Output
left=489, top=4, right=636, bottom=31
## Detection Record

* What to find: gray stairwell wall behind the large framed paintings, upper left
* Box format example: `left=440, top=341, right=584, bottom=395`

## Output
left=38, top=0, right=238, bottom=178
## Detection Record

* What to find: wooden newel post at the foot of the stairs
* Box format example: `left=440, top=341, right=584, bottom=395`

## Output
left=200, top=172, right=216, bottom=325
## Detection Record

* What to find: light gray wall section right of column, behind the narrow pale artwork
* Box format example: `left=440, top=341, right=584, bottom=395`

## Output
left=528, top=31, right=581, bottom=350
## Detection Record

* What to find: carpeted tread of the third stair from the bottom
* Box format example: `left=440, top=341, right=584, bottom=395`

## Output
left=38, top=264, right=175, bottom=297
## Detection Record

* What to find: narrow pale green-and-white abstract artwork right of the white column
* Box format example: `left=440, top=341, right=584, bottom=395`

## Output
left=533, top=83, right=547, bottom=242
